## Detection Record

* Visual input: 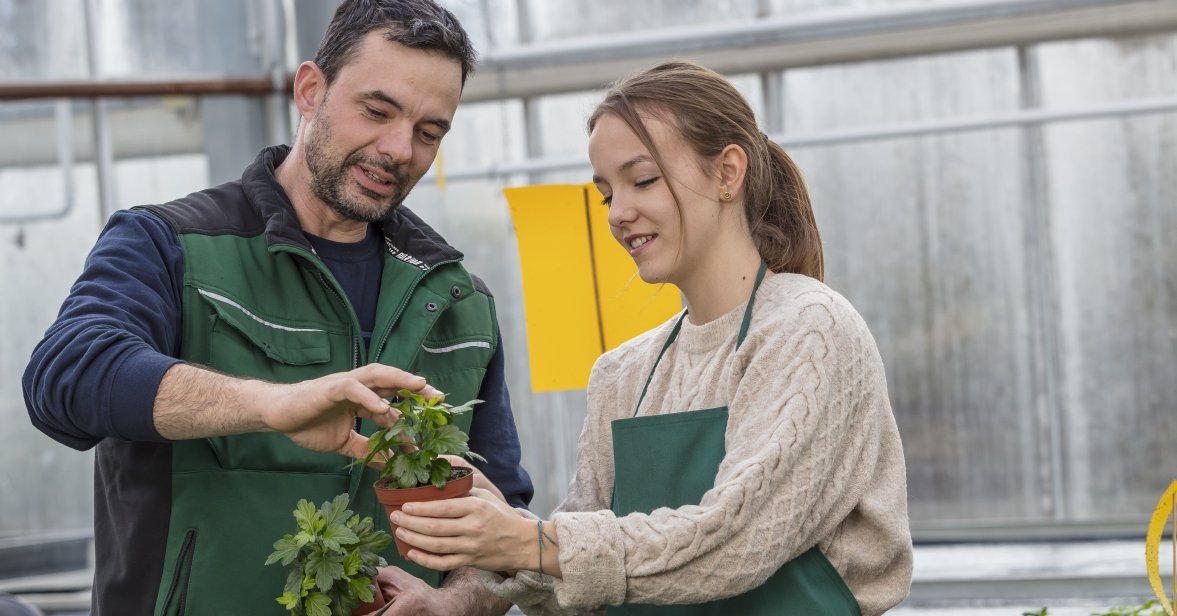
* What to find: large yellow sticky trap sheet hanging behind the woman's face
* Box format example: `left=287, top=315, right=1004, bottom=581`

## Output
left=503, top=184, right=681, bottom=392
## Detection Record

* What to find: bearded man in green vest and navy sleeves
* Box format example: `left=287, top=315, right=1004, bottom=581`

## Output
left=24, top=0, right=532, bottom=616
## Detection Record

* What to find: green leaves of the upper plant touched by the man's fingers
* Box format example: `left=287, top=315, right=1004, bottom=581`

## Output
left=353, top=390, right=485, bottom=488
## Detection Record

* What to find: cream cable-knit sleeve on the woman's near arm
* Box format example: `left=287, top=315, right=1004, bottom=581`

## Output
left=553, top=300, right=889, bottom=608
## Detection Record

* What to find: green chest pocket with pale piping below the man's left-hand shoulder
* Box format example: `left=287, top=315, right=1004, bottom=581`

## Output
left=199, top=289, right=334, bottom=383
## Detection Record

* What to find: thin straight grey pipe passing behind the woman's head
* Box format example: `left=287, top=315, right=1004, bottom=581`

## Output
left=421, top=97, right=1177, bottom=183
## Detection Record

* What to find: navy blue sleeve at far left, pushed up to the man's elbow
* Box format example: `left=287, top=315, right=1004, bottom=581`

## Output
left=21, top=211, right=184, bottom=450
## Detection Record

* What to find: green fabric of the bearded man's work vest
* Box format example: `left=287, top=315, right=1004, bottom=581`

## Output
left=144, top=201, right=497, bottom=616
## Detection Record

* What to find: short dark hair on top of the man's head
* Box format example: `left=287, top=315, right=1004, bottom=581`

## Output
left=314, top=0, right=478, bottom=85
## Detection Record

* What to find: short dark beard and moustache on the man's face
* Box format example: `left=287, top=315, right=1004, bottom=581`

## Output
left=305, top=107, right=412, bottom=223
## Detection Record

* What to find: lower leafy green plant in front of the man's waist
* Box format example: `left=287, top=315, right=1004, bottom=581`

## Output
left=266, top=494, right=392, bottom=616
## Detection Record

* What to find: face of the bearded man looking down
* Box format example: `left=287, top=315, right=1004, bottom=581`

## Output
left=305, top=32, right=461, bottom=223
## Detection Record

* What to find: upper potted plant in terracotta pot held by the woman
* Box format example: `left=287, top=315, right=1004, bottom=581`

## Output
left=354, top=390, right=485, bottom=556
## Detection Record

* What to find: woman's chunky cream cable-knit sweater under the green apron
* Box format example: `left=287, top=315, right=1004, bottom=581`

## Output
left=487, top=274, right=911, bottom=616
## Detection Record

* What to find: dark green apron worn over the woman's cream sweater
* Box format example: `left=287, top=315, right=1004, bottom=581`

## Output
left=609, top=264, right=860, bottom=616
